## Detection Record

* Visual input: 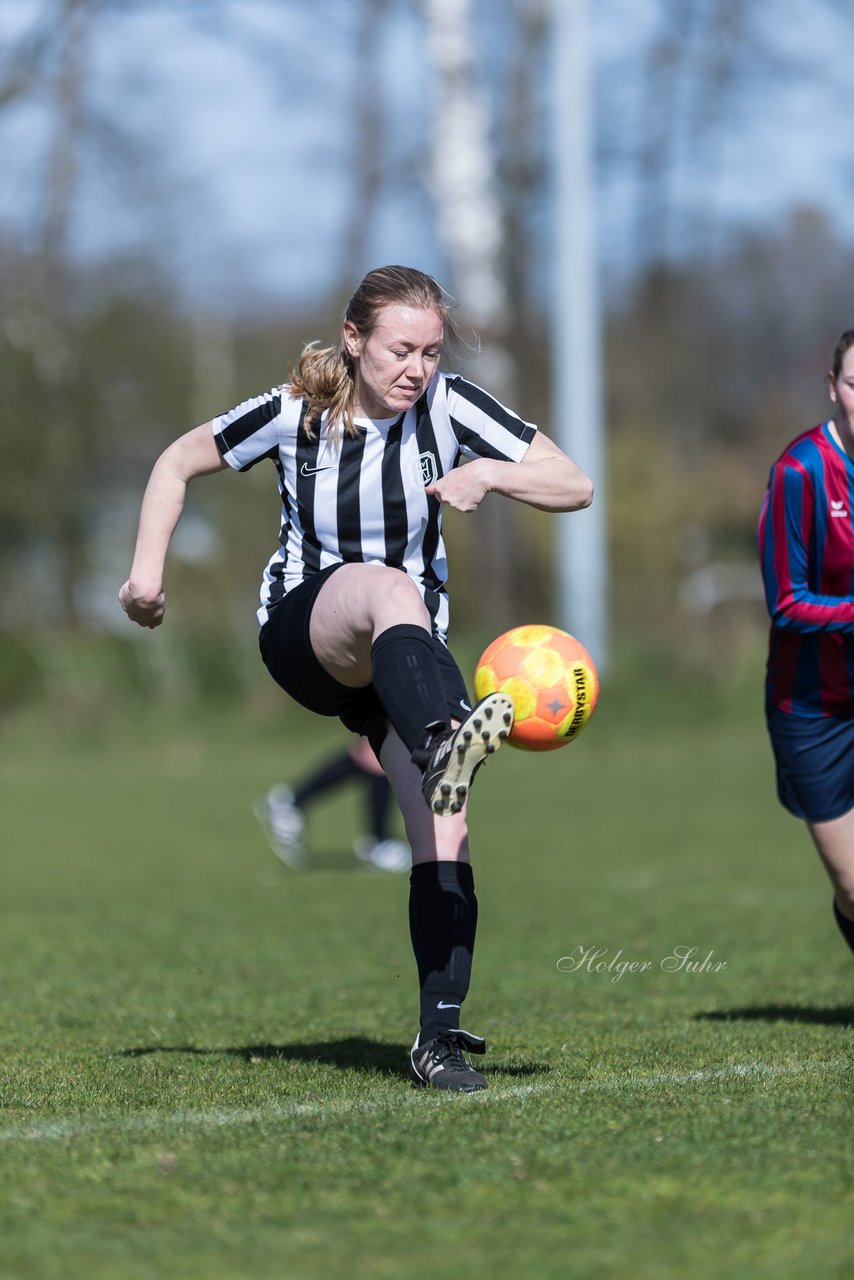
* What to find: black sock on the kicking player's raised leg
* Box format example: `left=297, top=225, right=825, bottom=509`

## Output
left=371, top=622, right=448, bottom=751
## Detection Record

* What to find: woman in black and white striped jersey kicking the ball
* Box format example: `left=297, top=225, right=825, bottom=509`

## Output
left=119, top=266, right=592, bottom=1092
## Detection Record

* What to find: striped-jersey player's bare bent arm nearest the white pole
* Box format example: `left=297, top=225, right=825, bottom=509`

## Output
left=426, top=431, right=593, bottom=511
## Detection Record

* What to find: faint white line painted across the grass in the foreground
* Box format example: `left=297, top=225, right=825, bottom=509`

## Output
left=0, top=1057, right=853, bottom=1142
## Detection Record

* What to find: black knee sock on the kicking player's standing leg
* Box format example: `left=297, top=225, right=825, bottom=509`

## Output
left=410, top=861, right=478, bottom=1044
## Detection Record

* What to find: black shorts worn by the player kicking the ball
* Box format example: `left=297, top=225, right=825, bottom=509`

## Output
left=259, top=564, right=470, bottom=755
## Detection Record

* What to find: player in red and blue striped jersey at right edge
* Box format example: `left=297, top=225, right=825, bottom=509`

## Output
left=759, top=329, right=854, bottom=967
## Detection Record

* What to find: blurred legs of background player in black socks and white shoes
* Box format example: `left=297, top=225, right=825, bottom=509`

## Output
left=255, top=737, right=412, bottom=872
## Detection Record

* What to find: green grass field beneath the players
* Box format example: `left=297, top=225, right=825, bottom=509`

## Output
left=0, top=670, right=854, bottom=1280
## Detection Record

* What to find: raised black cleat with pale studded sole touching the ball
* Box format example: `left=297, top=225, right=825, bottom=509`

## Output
left=412, top=694, right=513, bottom=814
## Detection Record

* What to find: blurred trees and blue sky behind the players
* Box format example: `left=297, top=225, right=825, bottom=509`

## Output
left=0, top=0, right=854, bottom=721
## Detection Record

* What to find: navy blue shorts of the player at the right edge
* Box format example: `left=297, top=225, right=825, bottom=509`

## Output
left=767, top=708, right=854, bottom=822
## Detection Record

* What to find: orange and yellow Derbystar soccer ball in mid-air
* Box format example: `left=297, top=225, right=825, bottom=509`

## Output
left=475, top=625, right=599, bottom=751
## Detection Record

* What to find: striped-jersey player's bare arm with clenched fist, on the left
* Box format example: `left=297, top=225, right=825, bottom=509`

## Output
left=119, top=422, right=225, bottom=627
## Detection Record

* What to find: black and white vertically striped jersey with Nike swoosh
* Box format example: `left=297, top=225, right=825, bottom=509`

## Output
left=211, top=372, right=536, bottom=640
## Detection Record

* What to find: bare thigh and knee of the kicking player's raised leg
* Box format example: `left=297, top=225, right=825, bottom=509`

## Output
left=309, top=564, right=430, bottom=689
